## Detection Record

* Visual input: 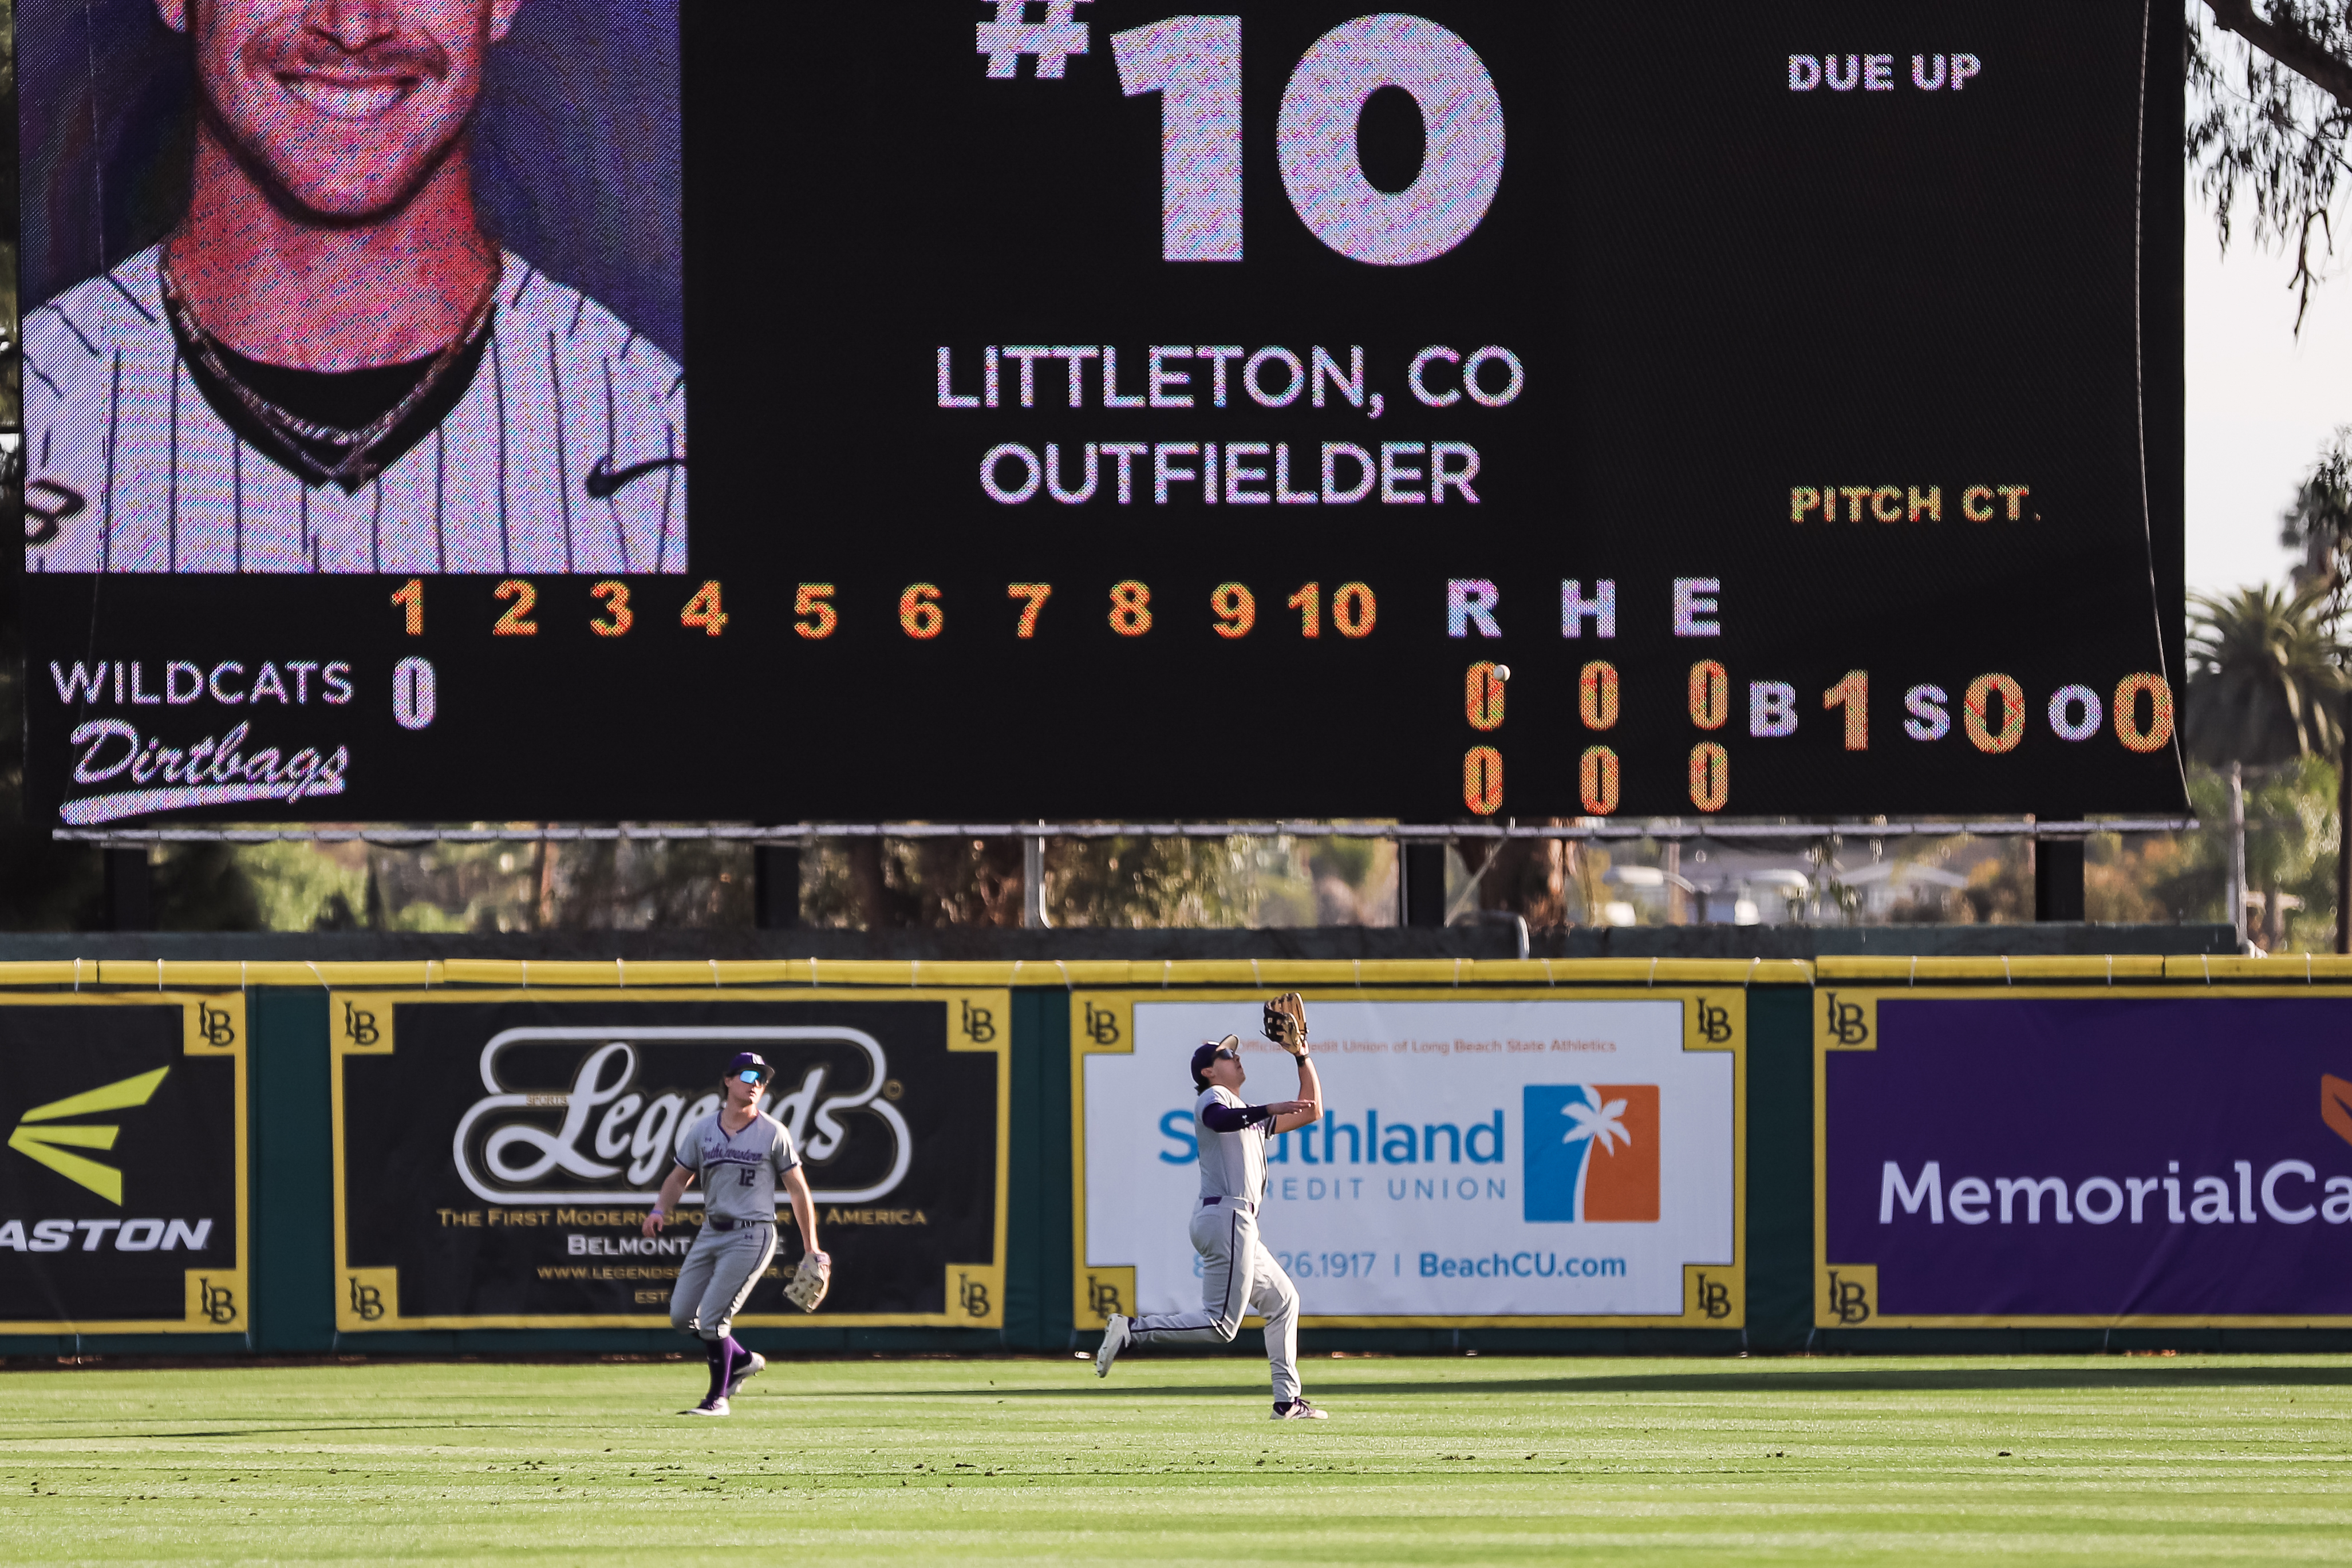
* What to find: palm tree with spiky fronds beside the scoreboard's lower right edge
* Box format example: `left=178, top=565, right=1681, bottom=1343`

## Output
left=2180, top=583, right=2347, bottom=767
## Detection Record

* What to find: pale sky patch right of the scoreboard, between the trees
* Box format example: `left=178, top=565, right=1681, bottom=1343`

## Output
left=2183, top=198, right=2352, bottom=593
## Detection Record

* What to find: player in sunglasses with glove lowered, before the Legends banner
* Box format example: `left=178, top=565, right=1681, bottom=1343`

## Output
left=645, top=1051, right=832, bottom=1415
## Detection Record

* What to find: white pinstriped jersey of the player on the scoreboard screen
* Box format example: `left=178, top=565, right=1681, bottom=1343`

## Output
left=23, top=249, right=687, bottom=574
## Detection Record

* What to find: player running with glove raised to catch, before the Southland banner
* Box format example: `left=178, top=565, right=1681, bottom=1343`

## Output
left=1094, top=992, right=1327, bottom=1420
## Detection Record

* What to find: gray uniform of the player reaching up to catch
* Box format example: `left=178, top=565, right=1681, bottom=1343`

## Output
left=1131, top=1086, right=1299, bottom=1401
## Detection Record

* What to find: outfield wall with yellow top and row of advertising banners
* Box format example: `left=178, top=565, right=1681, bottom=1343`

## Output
left=0, top=957, right=2352, bottom=1354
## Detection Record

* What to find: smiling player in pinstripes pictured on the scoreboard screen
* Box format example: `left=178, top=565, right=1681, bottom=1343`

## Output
left=23, top=0, right=687, bottom=574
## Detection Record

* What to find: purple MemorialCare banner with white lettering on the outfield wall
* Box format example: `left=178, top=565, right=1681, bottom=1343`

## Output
left=1813, top=985, right=2352, bottom=1328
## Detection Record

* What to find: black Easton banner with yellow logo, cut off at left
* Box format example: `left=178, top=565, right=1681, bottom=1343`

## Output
left=0, top=992, right=252, bottom=1335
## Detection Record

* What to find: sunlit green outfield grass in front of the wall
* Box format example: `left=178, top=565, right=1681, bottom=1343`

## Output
left=0, top=1354, right=2352, bottom=1568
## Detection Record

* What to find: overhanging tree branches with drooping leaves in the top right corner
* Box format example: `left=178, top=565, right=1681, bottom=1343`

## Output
left=2183, top=0, right=2352, bottom=331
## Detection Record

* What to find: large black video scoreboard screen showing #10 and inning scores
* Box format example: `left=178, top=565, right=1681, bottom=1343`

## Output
left=17, top=0, right=2183, bottom=827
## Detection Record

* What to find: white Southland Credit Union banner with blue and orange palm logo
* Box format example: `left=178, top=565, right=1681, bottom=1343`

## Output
left=1070, top=990, right=1747, bottom=1328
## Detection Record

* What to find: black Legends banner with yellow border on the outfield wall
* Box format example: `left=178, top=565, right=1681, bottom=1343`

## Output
left=329, top=990, right=1011, bottom=1333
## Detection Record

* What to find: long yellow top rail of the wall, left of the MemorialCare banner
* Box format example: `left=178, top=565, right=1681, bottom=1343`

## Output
left=0, top=959, right=1813, bottom=990
